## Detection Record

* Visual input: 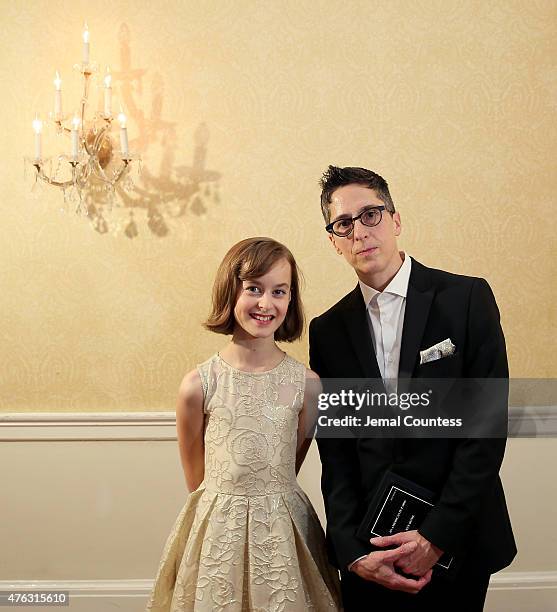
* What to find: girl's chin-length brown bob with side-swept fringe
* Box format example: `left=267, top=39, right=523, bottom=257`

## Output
left=203, top=237, right=304, bottom=342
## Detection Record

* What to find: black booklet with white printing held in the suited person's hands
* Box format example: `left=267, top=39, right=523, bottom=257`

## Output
left=356, top=472, right=453, bottom=570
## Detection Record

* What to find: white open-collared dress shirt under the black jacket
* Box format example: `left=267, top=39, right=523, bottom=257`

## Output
left=348, top=253, right=412, bottom=570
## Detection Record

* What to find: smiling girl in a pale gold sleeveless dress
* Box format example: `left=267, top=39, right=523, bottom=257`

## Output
left=147, top=238, right=339, bottom=612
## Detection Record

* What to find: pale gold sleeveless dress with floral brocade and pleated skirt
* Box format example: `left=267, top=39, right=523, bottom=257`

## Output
left=147, top=354, right=340, bottom=612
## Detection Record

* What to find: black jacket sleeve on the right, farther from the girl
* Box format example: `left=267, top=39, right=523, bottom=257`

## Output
left=419, top=279, right=508, bottom=554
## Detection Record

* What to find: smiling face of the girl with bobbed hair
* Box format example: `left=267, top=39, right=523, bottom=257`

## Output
left=234, top=259, right=292, bottom=338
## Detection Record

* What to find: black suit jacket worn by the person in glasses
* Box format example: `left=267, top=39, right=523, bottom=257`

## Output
left=309, top=260, right=516, bottom=573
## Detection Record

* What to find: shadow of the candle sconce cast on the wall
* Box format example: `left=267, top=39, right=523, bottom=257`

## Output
left=86, top=24, right=221, bottom=238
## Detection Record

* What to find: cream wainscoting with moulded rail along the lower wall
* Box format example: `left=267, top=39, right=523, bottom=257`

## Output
left=0, top=409, right=557, bottom=612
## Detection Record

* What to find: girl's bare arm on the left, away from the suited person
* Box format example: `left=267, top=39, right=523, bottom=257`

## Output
left=176, top=370, right=205, bottom=491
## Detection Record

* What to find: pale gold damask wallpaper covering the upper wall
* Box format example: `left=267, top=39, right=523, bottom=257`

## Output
left=0, top=0, right=557, bottom=412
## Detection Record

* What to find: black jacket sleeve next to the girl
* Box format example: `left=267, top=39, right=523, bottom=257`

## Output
left=309, top=319, right=371, bottom=570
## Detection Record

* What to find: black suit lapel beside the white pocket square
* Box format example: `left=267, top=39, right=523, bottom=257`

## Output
left=398, top=259, right=435, bottom=378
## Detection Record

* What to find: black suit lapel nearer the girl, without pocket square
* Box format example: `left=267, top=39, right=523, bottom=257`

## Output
left=336, top=285, right=381, bottom=378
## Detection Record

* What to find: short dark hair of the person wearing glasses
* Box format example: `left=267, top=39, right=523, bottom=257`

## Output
left=319, top=166, right=395, bottom=224
